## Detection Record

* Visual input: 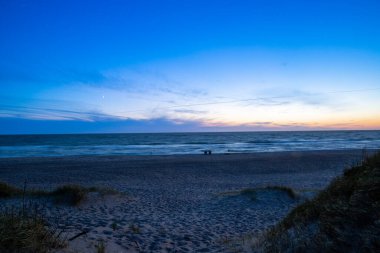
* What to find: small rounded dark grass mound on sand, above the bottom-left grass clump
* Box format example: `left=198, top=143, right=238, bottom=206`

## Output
left=51, top=184, right=89, bottom=206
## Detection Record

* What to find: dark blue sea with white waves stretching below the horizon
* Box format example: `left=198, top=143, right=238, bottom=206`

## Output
left=0, top=131, right=380, bottom=158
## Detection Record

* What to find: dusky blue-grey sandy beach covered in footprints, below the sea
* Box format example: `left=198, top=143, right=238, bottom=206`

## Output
left=0, top=150, right=370, bottom=252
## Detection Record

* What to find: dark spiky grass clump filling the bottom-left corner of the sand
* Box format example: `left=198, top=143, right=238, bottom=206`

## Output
left=0, top=206, right=65, bottom=253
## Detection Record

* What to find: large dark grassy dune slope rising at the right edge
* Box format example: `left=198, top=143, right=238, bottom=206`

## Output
left=262, top=152, right=380, bottom=252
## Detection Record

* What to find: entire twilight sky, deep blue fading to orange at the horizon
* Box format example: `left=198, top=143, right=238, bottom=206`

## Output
left=0, top=0, right=380, bottom=134
